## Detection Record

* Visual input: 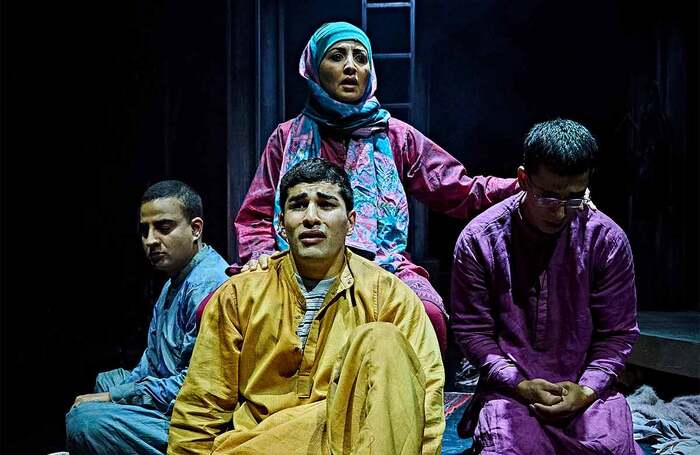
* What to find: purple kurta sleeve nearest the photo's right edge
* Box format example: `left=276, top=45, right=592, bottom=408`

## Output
left=578, top=232, right=639, bottom=395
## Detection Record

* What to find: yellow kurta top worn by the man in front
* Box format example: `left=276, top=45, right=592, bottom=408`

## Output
left=168, top=250, right=445, bottom=454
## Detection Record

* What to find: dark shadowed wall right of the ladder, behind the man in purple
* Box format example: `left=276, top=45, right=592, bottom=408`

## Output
left=421, top=0, right=700, bottom=310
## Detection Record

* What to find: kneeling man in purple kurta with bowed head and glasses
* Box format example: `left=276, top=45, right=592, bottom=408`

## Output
left=451, top=119, right=642, bottom=455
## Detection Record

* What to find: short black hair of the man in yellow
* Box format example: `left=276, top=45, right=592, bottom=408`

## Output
left=280, top=158, right=353, bottom=212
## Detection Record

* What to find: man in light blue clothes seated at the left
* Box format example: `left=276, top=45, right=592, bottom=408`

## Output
left=66, top=180, right=228, bottom=454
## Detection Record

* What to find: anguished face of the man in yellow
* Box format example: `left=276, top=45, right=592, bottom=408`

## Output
left=281, top=182, right=355, bottom=265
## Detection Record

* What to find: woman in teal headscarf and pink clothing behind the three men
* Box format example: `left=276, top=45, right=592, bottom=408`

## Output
left=230, top=22, right=518, bottom=352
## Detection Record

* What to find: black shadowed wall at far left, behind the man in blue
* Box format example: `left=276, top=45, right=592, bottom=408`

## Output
left=6, top=1, right=227, bottom=453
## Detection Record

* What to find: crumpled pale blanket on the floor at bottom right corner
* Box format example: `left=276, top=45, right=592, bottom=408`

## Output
left=627, top=385, right=700, bottom=455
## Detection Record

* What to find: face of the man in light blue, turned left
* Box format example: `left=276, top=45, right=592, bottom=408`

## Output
left=139, top=197, right=203, bottom=277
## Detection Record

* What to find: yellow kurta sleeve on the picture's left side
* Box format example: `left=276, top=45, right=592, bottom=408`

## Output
left=168, top=283, right=243, bottom=454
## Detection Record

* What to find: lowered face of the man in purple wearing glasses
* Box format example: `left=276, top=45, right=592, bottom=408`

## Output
left=518, top=166, right=589, bottom=234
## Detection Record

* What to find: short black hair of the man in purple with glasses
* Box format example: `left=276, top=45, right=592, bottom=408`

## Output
left=523, top=118, right=598, bottom=176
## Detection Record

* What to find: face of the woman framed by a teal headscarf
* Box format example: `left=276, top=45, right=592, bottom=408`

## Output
left=319, top=40, right=370, bottom=103
